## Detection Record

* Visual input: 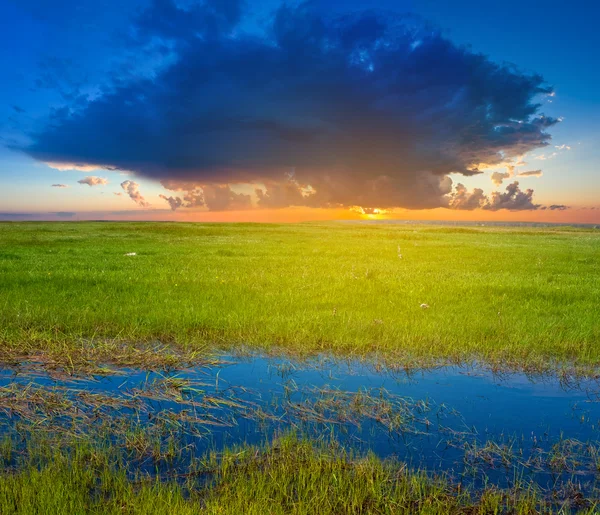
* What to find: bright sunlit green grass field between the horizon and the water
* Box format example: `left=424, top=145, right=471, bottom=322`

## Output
left=0, top=223, right=600, bottom=367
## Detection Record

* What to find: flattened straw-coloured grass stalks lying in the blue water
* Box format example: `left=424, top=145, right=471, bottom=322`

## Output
left=0, top=373, right=452, bottom=454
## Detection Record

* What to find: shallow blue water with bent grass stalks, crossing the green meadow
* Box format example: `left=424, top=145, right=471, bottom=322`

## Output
left=0, top=356, right=600, bottom=490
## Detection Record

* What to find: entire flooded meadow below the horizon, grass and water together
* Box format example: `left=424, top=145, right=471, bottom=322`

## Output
left=0, top=222, right=600, bottom=515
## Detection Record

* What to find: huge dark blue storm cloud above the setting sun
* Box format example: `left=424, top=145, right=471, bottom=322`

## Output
left=26, top=0, right=557, bottom=209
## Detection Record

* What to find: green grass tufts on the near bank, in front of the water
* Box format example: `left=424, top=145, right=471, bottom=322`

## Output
left=0, top=436, right=580, bottom=515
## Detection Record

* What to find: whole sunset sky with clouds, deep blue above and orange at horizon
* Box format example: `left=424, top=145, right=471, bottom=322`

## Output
left=0, top=0, right=600, bottom=224
